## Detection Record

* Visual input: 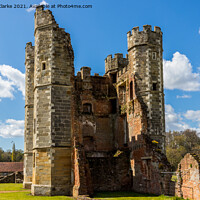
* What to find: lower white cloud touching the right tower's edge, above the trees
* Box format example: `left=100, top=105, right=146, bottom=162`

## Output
left=165, top=105, right=190, bottom=131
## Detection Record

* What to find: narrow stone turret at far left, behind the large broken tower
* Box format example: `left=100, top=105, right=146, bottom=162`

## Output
left=23, top=42, right=34, bottom=189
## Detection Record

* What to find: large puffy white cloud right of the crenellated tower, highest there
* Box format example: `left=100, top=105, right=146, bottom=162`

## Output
left=163, top=52, right=200, bottom=91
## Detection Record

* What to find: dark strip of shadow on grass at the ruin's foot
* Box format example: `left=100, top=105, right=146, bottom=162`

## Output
left=93, top=192, right=157, bottom=198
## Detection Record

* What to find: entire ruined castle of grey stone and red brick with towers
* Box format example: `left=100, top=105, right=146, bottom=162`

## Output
left=24, top=6, right=172, bottom=196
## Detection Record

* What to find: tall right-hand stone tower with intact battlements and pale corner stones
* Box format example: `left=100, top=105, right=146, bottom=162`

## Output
left=127, top=25, right=165, bottom=151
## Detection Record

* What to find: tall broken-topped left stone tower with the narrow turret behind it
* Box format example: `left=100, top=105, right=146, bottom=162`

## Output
left=24, top=6, right=74, bottom=195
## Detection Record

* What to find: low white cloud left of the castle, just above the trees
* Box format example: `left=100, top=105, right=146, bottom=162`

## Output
left=0, top=119, right=24, bottom=138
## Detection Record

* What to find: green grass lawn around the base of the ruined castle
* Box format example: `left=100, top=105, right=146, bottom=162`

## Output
left=0, top=183, right=185, bottom=200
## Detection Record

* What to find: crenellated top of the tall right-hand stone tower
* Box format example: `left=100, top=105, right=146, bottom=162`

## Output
left=127, top=25, right=162, bottom=51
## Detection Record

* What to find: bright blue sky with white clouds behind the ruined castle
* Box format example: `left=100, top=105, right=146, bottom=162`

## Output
left=0, top=0, right=200, bottom=150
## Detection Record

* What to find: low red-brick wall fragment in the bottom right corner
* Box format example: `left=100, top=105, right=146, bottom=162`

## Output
left=176, top=153, right=200, bottom=200
